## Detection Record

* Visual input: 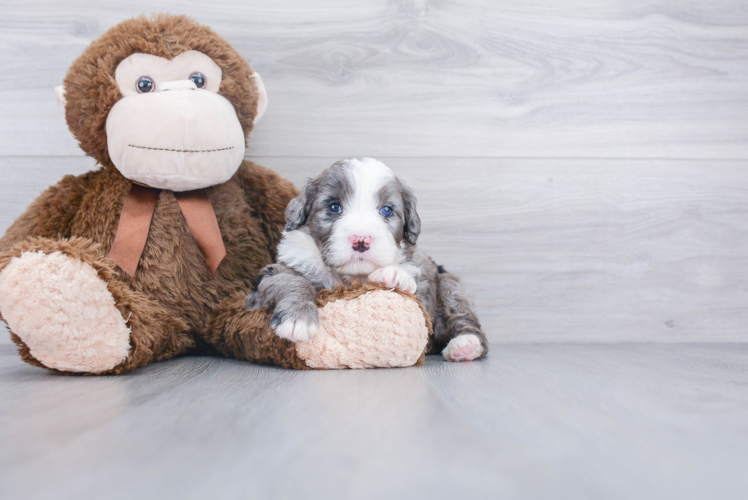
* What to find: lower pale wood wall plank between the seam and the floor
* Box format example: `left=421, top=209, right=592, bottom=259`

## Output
left=0, top=157, right=748, bottom=342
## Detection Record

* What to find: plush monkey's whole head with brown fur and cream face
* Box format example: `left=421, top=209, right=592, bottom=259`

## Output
left=55, top=15, right=267, bottom=191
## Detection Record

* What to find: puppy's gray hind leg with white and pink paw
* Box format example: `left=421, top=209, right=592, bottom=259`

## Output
left=434, top=273, right=488, bottom=361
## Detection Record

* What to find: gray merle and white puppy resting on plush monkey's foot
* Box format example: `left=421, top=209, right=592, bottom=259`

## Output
left=247, top=158, right=488, bottom=361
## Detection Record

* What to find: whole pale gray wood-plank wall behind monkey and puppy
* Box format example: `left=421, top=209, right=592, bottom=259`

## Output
left=0, top=0, right=748, bottom=343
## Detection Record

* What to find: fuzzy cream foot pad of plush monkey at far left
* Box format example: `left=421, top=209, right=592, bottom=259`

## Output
left=0, top=252, right=130, bottom=373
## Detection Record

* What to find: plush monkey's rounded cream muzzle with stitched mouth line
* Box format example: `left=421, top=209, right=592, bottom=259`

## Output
left=106, top=80, right=245, bottom=192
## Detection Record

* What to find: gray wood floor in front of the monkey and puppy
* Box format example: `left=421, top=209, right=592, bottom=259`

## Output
left=0, top=344, right=748, bottom=499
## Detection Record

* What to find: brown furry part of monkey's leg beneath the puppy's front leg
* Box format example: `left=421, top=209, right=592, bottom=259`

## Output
left=205, top=292, right=308, bottom=370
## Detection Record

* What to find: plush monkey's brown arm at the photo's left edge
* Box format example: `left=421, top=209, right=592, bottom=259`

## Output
left=0, top=175, right=88, bottom=252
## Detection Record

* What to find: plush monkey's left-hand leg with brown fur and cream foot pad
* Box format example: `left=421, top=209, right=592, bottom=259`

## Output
left=0, top=238, right=192, bottom=374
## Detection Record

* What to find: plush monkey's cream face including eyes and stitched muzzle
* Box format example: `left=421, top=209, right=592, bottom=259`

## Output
left=106, top=50, right=262, bottom=191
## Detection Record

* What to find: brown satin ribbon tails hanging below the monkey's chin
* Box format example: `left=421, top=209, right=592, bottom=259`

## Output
left=109, top=184, right=226, bottom=277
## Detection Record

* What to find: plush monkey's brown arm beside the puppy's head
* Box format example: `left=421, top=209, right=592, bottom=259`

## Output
left=236, top=160, right=298, bottom=260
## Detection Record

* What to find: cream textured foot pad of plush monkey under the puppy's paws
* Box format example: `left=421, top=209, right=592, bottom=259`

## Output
left=296, top=290, right=429, bottom=369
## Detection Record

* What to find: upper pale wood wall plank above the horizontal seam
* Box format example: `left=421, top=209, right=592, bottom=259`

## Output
left=0, top=0, right=748, bottom=159
